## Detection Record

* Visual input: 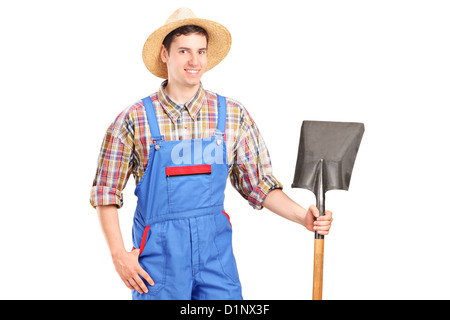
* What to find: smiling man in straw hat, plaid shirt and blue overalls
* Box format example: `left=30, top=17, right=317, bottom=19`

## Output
left=91, top=8, right=332, bottom=299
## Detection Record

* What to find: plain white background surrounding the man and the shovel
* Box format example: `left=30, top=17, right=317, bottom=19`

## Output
left=0, top=0, right=450, bottom=299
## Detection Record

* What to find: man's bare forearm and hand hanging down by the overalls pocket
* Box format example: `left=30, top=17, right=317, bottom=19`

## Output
left=96, top=205, right=154, bottom=293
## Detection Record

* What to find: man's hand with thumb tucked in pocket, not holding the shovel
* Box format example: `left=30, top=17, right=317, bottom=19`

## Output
left=113, top=249, right=155, bottom=293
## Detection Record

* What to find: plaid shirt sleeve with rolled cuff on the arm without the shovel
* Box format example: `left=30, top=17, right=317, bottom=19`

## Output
left=90, top=110, right=133, bottom=208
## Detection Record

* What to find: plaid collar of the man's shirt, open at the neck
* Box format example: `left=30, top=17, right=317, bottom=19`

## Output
left=158, top=80, right=205, bottom=123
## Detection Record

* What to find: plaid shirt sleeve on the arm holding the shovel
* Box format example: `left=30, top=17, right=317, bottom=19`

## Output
left=230, top=110, right=283, bottom=210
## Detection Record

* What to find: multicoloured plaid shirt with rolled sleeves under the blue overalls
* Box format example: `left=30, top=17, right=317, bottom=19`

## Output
left=90, top=81, right=282, bottom=209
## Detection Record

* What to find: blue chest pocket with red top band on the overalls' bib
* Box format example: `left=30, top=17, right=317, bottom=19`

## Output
left=166, top=164, right=212, bottom=213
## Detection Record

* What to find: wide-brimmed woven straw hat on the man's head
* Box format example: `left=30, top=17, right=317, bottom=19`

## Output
left=142, top=8, right=231, bottom=79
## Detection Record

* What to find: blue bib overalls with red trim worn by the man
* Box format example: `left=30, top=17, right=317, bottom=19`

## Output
left=132, top=95, right=242, bottom=300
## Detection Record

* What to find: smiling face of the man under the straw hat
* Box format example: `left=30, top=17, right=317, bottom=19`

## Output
left=161, top=33, right=207, bottom=87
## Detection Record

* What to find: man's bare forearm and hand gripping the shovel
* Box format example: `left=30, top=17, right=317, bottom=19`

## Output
left=262, top=189, right=333, bottom=235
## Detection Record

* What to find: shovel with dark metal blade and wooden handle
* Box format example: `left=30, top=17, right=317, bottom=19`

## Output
left=292, top=121, right=364, bottom=300
